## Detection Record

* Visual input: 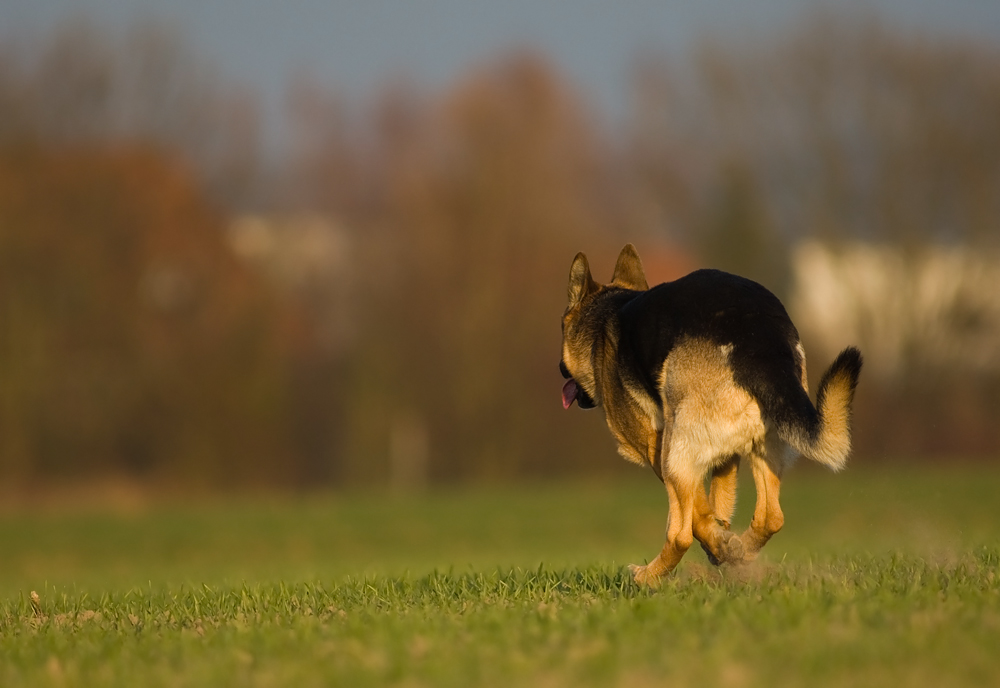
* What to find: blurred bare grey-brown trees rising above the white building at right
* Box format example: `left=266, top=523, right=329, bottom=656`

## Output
left=632, top=15, right=1000, bottom=286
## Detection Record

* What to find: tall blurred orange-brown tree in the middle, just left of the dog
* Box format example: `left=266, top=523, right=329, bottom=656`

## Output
left=292, top=55, right=619, bottom=486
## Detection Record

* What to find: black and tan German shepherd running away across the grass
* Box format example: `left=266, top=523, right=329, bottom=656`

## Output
left=559, top=244, right=862, bottom=585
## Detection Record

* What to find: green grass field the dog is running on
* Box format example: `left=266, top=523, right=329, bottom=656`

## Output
left=0, top=464, right=1000, bottom=687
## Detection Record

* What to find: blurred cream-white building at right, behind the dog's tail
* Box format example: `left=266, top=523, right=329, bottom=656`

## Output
left=789, top=242, right=1000, bottom=378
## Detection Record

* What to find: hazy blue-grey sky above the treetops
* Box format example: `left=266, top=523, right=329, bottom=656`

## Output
left=0, top=0, right=1000, bottom=148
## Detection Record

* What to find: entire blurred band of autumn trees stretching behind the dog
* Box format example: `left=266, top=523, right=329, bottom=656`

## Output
left=0, top=22, right=1000, bottom=489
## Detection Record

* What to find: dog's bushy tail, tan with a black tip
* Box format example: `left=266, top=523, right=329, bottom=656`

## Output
left=777, top=346, right=863, bottom=471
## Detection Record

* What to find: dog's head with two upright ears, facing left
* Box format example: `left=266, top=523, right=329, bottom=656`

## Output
left=559, top=244, right=649, bottom=409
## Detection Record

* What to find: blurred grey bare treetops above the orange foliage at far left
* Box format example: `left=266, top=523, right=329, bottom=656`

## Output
left=0, top=19, right=258, bottom=205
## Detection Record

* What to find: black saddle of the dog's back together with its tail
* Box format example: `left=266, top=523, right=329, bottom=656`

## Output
left=616, top=270, right=861, bottom=468
